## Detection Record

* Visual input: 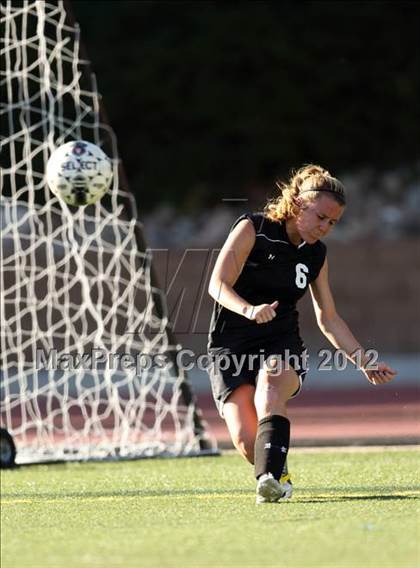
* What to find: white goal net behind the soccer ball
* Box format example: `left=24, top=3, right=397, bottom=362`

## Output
left=0, top=0, right=214, bottom=463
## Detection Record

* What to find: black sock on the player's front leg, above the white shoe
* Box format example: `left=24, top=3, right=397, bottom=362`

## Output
left=254, top=415, right=290, bottom=480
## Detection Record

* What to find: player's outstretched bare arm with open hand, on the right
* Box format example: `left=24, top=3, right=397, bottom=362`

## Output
left=310, top=259, right=397, bottom=385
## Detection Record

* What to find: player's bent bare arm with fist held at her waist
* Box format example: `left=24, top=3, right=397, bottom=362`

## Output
left=208, top=219, right=278, bottom=323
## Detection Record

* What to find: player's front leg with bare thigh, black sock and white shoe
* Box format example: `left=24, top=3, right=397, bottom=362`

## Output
left=254, top=368, right=300, bottom=503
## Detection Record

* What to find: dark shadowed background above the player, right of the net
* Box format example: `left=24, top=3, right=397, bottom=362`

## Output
left=72, top=0, right=420, bottom=210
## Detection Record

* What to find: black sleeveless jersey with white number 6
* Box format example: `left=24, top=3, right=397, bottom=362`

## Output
left=209, top=213, right=326, bottom=350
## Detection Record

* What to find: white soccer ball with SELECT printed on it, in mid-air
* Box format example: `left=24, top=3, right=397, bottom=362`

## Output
left=46, top=140, right=112, bottom=205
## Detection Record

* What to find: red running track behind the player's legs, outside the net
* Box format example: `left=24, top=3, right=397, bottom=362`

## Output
left=198, top=386, right=420, bottom=448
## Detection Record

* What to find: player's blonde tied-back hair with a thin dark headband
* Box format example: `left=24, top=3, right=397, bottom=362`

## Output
left=264, top=164, right=346, bottom=221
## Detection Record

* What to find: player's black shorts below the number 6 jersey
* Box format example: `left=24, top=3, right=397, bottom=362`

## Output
left=207, top=338, right=307, bottom=417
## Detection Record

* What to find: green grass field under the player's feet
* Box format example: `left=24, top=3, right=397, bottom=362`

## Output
left=1, top=448, right=420, bottom=568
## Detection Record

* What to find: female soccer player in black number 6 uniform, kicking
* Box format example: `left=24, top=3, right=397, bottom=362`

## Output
left=208, top=165, right=396, bottom=503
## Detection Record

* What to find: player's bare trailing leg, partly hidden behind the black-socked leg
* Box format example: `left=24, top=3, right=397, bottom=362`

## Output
left=223, top=384, right=258, bottom=464
